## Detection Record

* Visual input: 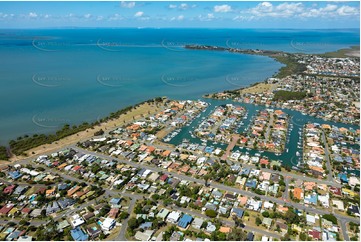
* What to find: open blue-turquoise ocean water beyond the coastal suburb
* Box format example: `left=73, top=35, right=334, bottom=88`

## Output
left=0, top=29, right=360, bottom=144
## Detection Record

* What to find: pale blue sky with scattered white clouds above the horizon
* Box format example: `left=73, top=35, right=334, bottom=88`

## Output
left=0, top=1, right=360, bottom=29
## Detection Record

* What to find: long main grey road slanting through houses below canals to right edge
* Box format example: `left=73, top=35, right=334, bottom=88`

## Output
left=74, top=145, right=359, bottom=223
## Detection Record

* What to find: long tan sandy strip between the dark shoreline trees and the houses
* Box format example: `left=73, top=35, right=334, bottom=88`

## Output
left=0, top=103, right=163, bottom=164
